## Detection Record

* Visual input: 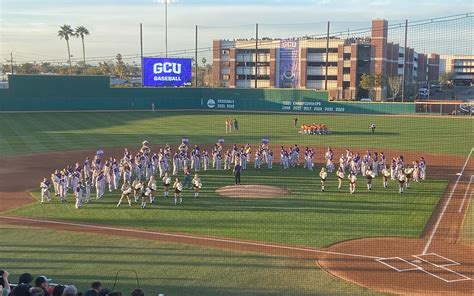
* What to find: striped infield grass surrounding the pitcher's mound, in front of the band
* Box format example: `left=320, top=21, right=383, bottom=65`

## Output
left=10, top=166, right=447, bottom=247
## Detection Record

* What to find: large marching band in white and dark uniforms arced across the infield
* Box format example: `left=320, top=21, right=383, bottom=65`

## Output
left=40, top=141, right=426, bottom=209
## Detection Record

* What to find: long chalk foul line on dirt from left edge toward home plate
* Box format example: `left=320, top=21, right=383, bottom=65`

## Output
left=0, top=216, right=383, bottom=259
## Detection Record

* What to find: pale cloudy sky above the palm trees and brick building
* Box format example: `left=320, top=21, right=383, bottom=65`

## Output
left=0, top=0, right=474, bottom=63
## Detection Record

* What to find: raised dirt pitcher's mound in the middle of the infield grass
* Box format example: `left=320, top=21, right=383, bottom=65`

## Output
left=216, top=185, right=290, bottom=198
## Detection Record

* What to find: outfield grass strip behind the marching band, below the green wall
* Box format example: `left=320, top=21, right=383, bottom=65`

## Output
left=0, top=112, right=474, bottom=155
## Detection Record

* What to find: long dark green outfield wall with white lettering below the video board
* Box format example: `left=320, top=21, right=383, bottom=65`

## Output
left=0, top=75, right=415, bottom=114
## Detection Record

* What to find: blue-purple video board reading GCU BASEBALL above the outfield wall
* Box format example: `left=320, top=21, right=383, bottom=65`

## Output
left=143, top=58, right=193, bottom=86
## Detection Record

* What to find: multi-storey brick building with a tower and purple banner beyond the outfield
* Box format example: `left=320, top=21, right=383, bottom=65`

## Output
left=213, top=20, right=439, bottom=100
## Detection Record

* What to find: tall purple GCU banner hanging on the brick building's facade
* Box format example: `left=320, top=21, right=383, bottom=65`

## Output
left=278, top=39, right=299, bottom=88
